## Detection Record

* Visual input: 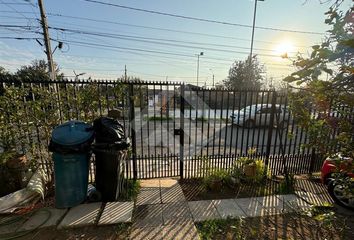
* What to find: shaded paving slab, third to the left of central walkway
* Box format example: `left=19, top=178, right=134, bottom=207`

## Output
left=19, top=208, right=68, bottom=231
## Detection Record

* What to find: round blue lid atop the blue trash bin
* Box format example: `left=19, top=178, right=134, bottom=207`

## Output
left=52, top=121, right=93, bottom=146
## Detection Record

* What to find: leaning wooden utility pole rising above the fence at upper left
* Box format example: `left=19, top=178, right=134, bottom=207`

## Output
left=38, top=0, right=55, bottom=80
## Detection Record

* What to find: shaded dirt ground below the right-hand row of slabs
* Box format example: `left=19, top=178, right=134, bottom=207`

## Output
left=197, top=214, right=354, bottom=240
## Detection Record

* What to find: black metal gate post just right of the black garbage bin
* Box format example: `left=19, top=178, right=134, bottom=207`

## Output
left=129, top=83, right=138, bottom=180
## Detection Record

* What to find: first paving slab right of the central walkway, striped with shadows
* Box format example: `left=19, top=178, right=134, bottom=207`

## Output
left=188, top=200, right=220, bottom=222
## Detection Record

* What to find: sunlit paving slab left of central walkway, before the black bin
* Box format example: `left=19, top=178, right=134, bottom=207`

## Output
left=98, top=202, right=134, bottom=225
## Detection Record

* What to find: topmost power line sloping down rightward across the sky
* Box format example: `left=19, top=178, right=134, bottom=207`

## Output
left=82, top=0, right=323, bottom=35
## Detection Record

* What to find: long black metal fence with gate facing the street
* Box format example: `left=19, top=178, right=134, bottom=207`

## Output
left=0, top=80, right=346, bottom=181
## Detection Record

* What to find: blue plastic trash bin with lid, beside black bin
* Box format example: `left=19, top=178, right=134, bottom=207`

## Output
left=49, top=121, right=94, bottom=208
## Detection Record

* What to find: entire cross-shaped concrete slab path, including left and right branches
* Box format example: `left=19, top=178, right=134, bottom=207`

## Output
left=0, top=179, right=336, bottom=239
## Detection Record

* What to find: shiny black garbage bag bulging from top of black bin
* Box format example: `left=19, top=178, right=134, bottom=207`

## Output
left=93, top=117, right=130, bottom=149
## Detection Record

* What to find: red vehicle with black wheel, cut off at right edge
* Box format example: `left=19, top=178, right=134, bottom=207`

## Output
left=321, top=158, right=354, bottom=210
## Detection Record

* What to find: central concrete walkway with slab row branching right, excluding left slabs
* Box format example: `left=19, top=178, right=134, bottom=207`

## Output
left=131, top=179, right=330, bottom=240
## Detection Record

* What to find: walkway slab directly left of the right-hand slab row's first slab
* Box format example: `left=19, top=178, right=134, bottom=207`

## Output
left=162, top=202, right=192, bottom=220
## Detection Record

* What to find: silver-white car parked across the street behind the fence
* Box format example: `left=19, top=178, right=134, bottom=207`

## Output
left=230, top=104, right=290, bottom=128
